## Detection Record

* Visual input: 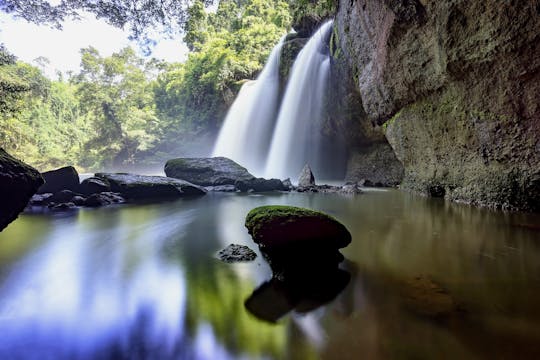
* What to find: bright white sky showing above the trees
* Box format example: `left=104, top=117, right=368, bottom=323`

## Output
left=0, top=12, right=188, bottom=79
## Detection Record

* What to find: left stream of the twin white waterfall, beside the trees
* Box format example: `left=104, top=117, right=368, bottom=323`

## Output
left=212, top=36, right=285, bottom=175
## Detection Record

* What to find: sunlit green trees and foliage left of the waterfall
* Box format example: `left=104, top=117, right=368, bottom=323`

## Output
left=0, top=0, right=290, bottom=170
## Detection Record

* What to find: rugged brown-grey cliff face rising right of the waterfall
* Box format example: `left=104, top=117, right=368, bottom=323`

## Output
left=335, top=0, right=540, bottom=211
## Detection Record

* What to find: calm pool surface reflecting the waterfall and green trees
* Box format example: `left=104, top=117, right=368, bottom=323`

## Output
left=0, top=191, right=540, bottom=359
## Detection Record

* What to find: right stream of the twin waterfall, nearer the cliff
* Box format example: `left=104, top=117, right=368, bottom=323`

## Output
left=265, top=21, right=332, bottom=180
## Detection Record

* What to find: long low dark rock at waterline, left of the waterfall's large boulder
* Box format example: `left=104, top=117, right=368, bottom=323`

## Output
left=96, top=173, right=206, bottom=199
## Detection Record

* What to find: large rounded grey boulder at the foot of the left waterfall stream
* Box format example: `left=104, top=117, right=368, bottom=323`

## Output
left=165, top=157, right=255, bottom=186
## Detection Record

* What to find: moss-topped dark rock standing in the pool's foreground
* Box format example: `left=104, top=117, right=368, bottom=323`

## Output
left=245, top=205, right=351, bottom=249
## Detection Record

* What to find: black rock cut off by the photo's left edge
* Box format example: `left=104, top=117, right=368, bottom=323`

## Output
left=0, top=148, right=43, bottom=231
